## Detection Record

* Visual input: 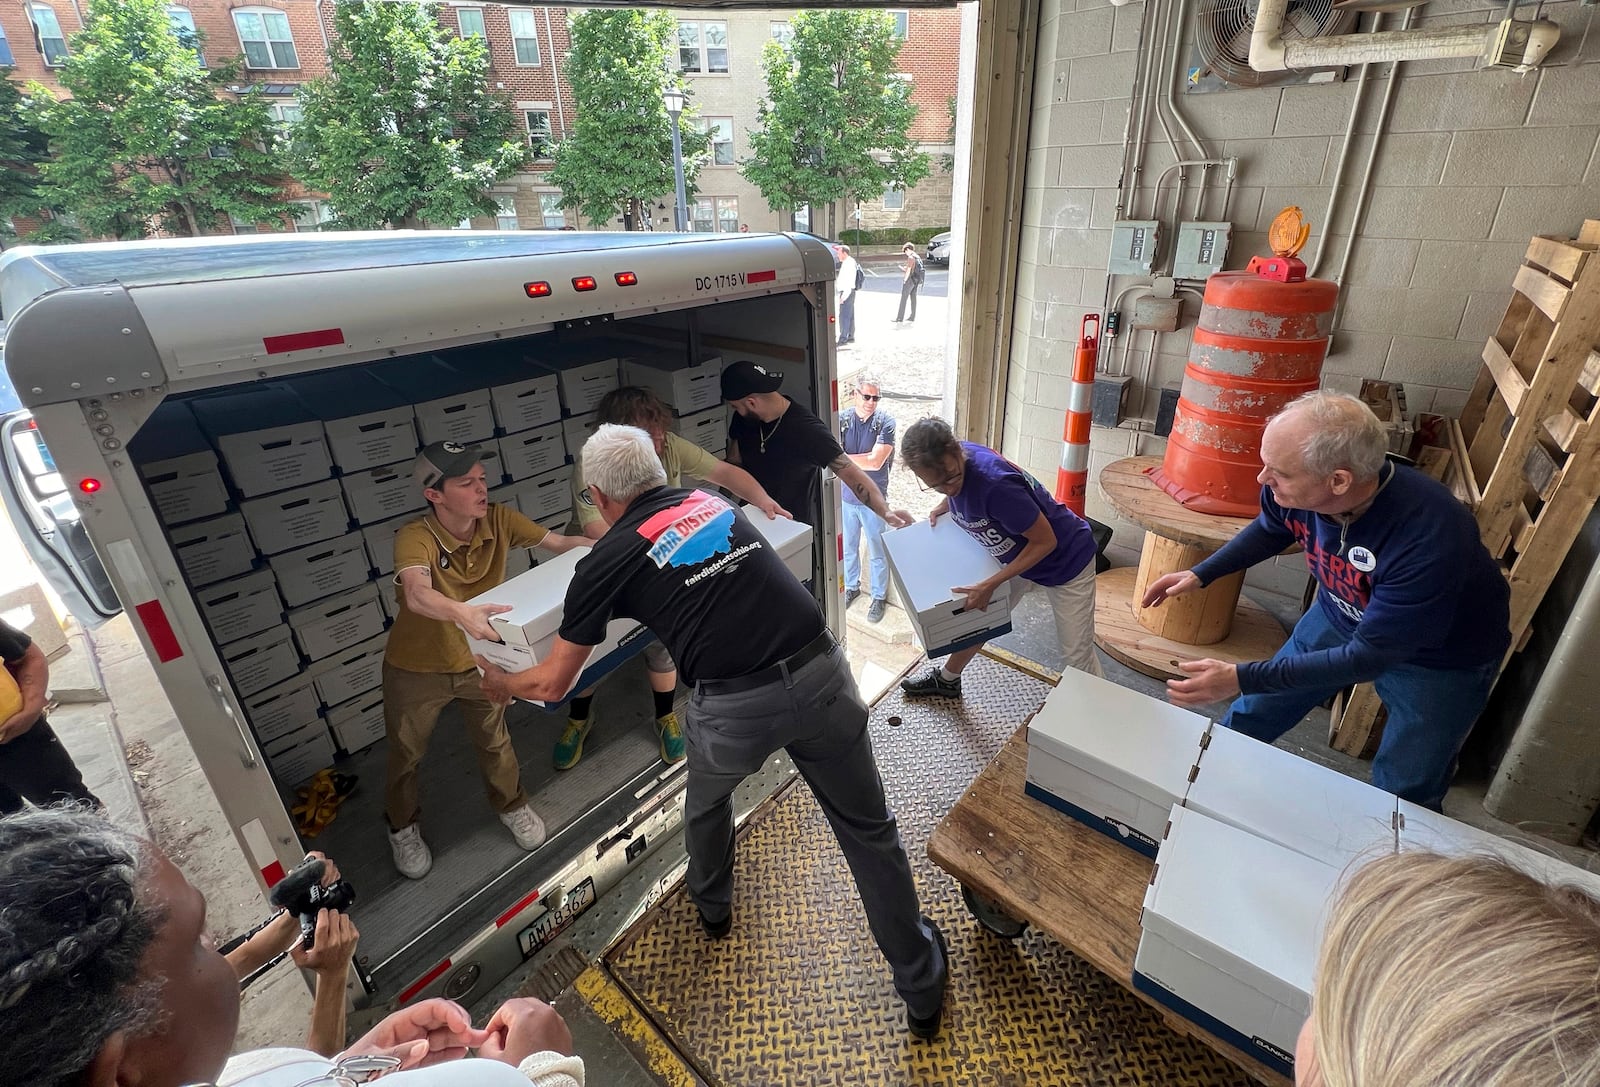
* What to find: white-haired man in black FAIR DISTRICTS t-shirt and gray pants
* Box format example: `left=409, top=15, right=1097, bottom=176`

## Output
left=478, top=426, right=949, bottom=1037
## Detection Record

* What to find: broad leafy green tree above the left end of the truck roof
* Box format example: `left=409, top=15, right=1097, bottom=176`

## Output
left=29, top=0, right=291, bottom=239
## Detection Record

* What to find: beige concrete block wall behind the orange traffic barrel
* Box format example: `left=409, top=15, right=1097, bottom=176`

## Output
left=1003, top=0, right=1600, bottom=568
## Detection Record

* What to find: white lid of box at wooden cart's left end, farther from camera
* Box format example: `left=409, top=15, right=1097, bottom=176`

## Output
left=1027, top=668, right=1206, bottom=807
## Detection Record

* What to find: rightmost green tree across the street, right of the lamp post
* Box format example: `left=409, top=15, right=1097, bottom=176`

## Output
left=739, top=10, right=930, bottom=237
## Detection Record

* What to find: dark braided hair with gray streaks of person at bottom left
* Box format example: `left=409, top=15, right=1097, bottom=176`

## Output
left=0, top=807, right=165, bottom=1087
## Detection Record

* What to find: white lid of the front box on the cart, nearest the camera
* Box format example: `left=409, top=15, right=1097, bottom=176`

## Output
left=1139, top=807, right=1339, bottom=1015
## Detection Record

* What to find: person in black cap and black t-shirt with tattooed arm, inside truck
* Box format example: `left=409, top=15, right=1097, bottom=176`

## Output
left=722, top=360, right=912, bottom=528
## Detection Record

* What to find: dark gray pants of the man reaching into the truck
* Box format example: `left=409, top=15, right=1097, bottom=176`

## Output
left=683, top=645, right=946, bottom=1017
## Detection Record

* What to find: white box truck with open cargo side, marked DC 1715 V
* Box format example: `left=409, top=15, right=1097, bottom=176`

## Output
left=0, top=231, right=845, bottom=1012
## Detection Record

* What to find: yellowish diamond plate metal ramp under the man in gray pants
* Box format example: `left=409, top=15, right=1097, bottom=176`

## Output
left=605, top=656, right=1248, bottom=1087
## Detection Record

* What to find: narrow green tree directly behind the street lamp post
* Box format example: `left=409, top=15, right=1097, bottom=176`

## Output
left=550, top=8, right=710, bottom=231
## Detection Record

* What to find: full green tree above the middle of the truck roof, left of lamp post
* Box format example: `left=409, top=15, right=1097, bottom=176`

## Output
left=290, top=0, right=528, bottom=231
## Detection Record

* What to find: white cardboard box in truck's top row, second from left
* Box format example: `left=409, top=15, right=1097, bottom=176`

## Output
left=189, top=386, right=333, bottom=498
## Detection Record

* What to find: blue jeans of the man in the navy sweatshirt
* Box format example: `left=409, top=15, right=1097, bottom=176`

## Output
left=1222, top=602, right=1499, bottom=812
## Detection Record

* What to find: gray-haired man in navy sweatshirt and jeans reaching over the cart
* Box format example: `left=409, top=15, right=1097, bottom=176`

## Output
left=1142, top=391, right=1510, bottom=812
